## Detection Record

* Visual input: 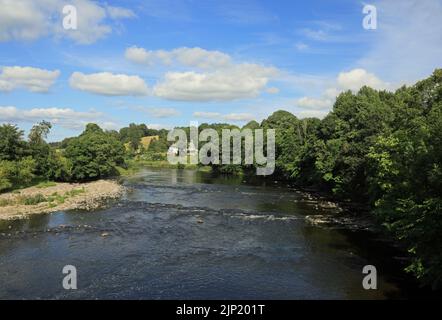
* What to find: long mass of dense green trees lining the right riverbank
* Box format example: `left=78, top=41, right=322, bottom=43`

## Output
left=261, top=70, right=442, bottom=287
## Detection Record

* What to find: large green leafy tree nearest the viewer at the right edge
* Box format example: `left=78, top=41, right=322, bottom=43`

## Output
left=369, top=70, right=442, bottom=288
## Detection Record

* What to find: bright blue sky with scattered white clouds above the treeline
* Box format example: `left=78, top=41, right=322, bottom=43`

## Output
left=0, top=0, right=442, bottom=140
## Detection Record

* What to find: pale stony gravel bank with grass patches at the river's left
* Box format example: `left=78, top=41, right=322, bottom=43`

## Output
left=0, top=180, right=124, bottom=220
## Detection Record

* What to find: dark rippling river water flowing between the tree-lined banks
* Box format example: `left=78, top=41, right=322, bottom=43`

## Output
left=0, top=169, right=414, bottom=299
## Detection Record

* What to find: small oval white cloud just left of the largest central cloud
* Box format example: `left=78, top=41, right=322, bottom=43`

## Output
left=69, top=72, right=148, bottom=96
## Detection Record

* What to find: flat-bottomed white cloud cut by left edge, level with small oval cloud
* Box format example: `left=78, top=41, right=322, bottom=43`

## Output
left=0, top=66, right=60, bottom=93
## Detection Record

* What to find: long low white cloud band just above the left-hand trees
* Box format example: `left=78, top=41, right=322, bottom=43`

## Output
left=0, top=106, right=117, bottom=130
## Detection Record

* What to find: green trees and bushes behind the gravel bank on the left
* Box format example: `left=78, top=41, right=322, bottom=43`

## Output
left=0, top=121, right=125, bottom=192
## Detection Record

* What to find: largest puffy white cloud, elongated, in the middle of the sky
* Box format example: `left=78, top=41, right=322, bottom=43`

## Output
left=153, top=64, right=277, bottom=101
